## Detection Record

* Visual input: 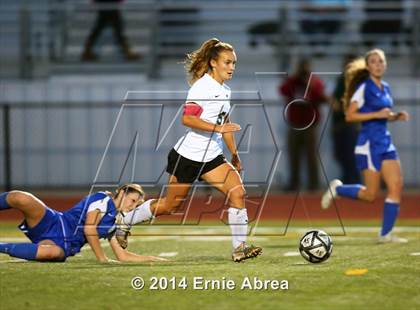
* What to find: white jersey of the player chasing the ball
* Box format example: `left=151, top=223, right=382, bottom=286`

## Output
left=174, top=73, right=230, bottom=162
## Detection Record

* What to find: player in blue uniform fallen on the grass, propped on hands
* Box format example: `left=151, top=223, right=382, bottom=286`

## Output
left=0, top=183, right=163, bottom=262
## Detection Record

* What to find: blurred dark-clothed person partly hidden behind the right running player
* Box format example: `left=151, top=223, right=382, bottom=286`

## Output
left=332, top=55, right=360, bottom=184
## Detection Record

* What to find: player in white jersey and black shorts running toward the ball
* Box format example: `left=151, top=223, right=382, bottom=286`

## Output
left=119, top=38, right=262, bottom=262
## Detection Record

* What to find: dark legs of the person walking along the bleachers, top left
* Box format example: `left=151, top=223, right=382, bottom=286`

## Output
left=82, top=0, right=140, bottom=61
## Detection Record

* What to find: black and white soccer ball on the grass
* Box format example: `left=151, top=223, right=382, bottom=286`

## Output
left=299, top=230, right=333, bottom=263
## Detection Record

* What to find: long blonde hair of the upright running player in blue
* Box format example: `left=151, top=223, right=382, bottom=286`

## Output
left=342, top=48, right=386, bottom=111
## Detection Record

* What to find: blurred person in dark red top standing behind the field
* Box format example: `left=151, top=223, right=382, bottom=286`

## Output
left=279, top=59, right=327, bottom=190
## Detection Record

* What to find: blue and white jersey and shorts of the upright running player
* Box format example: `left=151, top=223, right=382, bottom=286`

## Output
left=350, top=78, right=397, bottom=171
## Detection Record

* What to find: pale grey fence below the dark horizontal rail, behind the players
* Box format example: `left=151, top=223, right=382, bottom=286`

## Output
left=0, top=100, right=420, bottom=189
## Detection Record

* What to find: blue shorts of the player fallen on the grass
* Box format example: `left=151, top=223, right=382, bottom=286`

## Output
left=19, top=207, right=81, bottom=258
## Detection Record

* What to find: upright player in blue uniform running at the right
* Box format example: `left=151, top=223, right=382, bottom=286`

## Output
left=321, top=49, right=409, bottom=243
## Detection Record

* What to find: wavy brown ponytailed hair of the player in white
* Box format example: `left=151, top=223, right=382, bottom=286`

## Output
left=184, top=38, right=234, bottom=85
